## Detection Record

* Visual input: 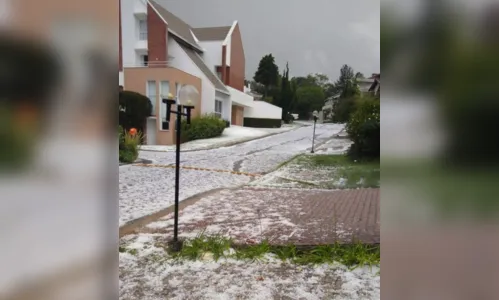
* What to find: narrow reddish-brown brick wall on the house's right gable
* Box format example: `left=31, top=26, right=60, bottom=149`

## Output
left=227, top=24, right=246, bottom=91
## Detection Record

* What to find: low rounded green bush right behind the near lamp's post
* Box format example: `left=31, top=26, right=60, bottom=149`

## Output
left=181, top=114, right=226, bottom=143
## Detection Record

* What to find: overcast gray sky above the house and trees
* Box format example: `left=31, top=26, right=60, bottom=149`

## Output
left=158, top=0, right=380, bottom=80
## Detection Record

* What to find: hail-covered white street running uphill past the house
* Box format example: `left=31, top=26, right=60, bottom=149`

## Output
left=119, top=124, right=343, bottom=225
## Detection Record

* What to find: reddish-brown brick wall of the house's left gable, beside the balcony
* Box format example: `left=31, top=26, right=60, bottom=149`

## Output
left=147, top=4, right=168, bottom=68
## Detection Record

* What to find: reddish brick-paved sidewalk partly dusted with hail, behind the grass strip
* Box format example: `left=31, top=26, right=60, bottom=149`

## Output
left=132, top=187, right=380, bottom=245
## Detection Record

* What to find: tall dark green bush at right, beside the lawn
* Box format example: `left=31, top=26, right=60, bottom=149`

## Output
left=346, top=98, right=380, bottom=159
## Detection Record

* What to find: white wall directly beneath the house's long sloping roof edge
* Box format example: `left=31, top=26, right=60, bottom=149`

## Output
left=168, top=35, right=219, bottom=119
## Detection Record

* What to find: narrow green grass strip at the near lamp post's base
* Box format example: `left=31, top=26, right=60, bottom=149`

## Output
left=150, top=234, right=380, bottom=269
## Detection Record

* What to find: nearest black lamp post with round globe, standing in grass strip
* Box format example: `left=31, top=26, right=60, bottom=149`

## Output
left=162, top=86, right=198, bottom=252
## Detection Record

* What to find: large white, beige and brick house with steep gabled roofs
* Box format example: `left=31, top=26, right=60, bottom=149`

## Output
left=119, top=0, right=281, bottom=145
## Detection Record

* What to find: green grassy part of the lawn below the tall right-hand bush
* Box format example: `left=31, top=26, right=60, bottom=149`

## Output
left=292, top=155, right=380, bottom=189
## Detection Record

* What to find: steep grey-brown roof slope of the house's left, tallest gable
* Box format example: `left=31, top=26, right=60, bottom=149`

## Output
left=148, top=0, right=203, bottom=52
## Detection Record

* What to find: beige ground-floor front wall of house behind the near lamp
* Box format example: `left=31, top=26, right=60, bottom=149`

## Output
left=125, top=67, right=203, bottom=145
